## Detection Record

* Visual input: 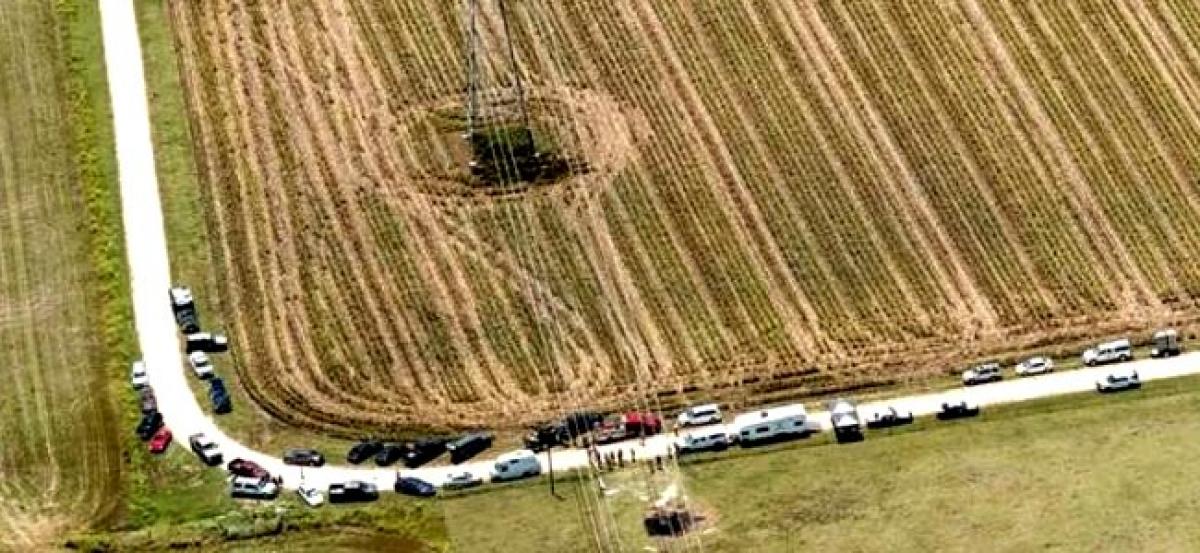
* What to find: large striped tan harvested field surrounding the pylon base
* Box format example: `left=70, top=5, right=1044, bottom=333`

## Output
left=169, top=0, right=1200, bottom=429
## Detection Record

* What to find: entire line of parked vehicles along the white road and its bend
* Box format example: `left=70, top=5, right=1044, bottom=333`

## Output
left=130, top=287, right=1182, bottom=506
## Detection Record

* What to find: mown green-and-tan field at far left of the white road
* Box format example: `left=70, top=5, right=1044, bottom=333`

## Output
left=0, top=0, right=126, bottom=544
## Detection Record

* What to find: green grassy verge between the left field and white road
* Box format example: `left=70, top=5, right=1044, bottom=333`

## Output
left=55, top=0, right=241, bottom=528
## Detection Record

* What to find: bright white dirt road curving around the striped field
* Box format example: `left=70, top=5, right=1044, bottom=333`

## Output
left=100, top=0, right=1200, bottom=488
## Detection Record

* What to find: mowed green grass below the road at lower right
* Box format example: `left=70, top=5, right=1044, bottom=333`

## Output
left=444, top=377, right=1200, bottom=553
